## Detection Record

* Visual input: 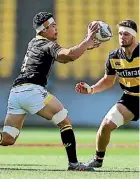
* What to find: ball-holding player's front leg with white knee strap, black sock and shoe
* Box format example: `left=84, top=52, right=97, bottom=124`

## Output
left=37, top=95, right=93, bottom=171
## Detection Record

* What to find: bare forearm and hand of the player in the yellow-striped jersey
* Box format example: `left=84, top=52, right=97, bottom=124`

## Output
left=75, top=74, right=116, bottom=94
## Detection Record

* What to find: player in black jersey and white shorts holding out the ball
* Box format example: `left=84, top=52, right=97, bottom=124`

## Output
left=0, top=12, right=100, bottom=171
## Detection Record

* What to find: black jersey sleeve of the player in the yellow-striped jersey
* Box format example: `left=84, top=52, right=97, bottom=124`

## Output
left=105, top=55, right=116, bottom=75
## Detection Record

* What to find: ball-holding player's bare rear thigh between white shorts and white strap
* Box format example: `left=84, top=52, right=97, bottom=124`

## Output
left=4, top=114, right=26, bottom=130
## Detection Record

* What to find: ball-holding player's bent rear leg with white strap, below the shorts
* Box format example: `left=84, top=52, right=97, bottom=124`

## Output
left=0, top=114, right=25, bottom=146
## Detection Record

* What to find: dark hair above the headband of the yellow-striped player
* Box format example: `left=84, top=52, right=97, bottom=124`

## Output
left=117, top=20, right=137, bottom=32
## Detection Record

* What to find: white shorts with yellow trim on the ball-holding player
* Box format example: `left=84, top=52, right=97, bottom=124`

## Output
left=7, top=83, right=53, bottom=114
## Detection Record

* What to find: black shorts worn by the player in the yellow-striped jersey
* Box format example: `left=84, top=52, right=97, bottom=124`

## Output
left=117, top=94, right=140, bottom=121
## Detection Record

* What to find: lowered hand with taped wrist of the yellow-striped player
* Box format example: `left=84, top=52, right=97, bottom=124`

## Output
left=75, top=82, right=93, bottom=94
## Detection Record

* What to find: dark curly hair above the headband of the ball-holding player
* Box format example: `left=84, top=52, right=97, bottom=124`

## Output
left=33, top=12, right=53, bottom=29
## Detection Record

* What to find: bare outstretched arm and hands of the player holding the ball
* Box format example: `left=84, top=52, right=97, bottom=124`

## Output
left=57, top=23, right=100, bottom=63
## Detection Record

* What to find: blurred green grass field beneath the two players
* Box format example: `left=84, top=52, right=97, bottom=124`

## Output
left=0, top=128, right=139, bottom=179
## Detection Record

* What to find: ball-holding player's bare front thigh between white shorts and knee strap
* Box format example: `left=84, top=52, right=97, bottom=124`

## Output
left=37, top=96, right=69, bottom=120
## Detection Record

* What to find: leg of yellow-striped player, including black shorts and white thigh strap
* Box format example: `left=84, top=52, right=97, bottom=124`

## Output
left=93, top=94, right=139, bottom=167
